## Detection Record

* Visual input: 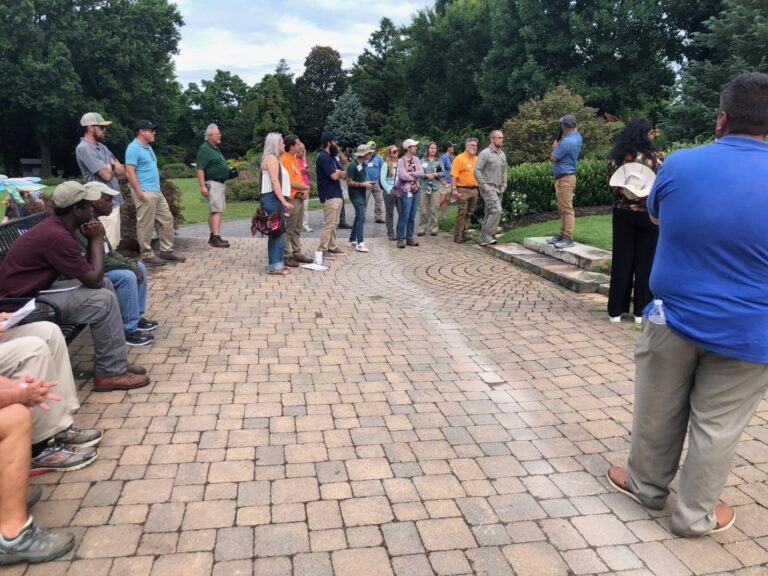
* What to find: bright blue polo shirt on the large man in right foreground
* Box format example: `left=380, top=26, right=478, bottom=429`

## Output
left=646, top=136, right=768, bottom=363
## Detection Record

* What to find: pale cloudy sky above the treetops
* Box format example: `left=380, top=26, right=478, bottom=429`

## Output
left=170, top=0, right=432, bottom=88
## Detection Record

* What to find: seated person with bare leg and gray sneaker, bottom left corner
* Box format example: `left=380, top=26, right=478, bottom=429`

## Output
left=0, top=379, right=75, bottom=565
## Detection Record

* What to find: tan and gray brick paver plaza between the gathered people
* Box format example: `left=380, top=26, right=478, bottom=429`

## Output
left=6, top=236, right=768, bottom=576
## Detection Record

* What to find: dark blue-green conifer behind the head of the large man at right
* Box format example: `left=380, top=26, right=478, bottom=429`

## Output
left=664, top=0, right=768, bottom=140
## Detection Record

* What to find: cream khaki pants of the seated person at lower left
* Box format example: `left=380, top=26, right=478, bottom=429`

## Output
left=0, top=322, right=80, bottom=444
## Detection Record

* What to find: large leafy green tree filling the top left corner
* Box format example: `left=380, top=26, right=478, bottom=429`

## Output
left=0, top=0, right=183, bottom=175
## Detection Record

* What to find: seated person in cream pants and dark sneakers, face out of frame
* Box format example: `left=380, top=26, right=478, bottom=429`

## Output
left=0, top=320, right=102, bottom=474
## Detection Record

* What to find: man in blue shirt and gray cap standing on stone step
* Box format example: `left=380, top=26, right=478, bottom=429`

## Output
left=547, top=114, right=582, bottom=249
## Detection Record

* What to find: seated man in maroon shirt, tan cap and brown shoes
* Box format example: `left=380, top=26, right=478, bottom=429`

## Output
left=0, top=181, right=149, bottom=392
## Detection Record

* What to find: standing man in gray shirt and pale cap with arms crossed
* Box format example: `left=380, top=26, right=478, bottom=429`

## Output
left=75, top=112, right=125, bottom=247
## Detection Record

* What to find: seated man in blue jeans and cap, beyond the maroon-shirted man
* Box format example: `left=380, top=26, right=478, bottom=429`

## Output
left=75, top=182, right=157, bottom=346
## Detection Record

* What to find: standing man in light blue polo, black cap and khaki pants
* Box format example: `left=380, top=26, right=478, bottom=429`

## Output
left=125, top=120, right=186, bottom=266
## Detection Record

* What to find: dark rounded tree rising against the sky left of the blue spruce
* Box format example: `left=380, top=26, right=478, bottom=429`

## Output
left=296, top=46, right=347, bottom=149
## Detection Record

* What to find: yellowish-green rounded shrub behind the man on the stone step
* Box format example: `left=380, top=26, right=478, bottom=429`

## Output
left=503, top=86, right=611, bottom=164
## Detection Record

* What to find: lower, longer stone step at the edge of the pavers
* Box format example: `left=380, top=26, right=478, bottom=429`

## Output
left=487, top=243, right=610, bottom=293
